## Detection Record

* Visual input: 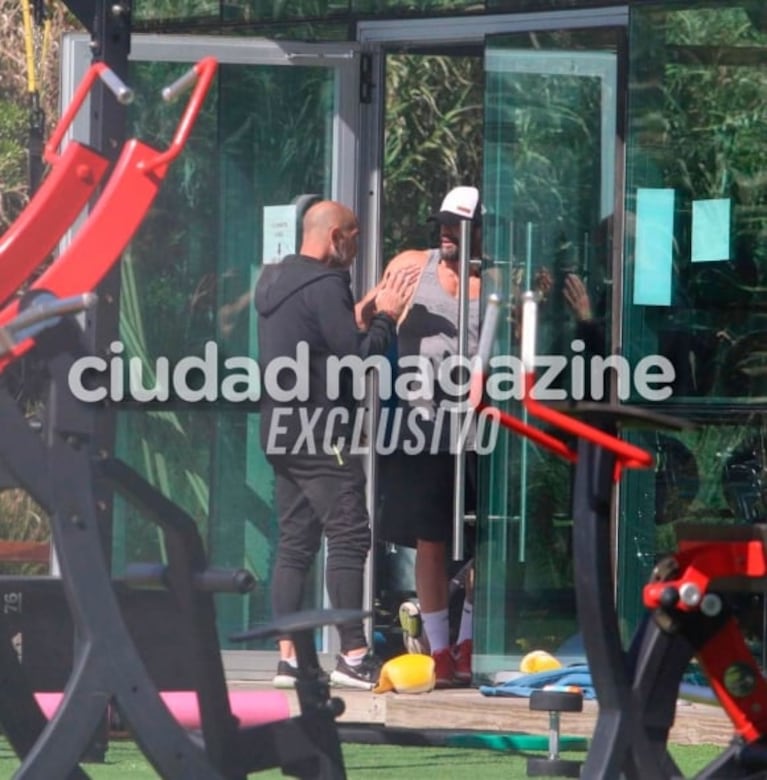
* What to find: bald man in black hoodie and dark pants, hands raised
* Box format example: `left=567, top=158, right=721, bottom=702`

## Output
left=255, top=201, right=415, bottom=689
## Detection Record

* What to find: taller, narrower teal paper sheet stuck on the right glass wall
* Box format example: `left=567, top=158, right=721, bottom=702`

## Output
left=634, top=187, right=674, bottom=306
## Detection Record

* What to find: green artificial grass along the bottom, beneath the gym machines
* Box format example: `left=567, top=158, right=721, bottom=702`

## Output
left=0, top=741, right=722, bottom=780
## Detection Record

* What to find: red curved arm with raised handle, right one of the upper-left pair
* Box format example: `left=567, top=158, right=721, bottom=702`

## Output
left=0, top=57, right=218, bottom=372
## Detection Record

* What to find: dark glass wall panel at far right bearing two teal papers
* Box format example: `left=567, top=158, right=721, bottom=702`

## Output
left=619, top=2, right=767, bottom=632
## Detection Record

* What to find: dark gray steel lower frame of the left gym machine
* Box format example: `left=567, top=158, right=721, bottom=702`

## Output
left=0, top=300, right=356, bottom=780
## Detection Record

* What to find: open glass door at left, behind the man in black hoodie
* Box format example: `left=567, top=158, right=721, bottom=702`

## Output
left=64, top=35, right=359, bottom=660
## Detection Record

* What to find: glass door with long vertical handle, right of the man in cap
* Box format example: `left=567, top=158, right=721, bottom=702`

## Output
left=484, top=30, right=618, bottom=676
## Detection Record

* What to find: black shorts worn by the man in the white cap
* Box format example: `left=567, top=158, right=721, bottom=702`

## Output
left=378, top=450, right=477, bottom=547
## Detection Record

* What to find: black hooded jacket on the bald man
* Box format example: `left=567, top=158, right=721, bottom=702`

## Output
left=254, top=255, right=396, bottom=455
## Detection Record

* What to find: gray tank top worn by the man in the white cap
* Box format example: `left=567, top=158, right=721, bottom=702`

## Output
left=387, top=244, right=479, bottom=453
